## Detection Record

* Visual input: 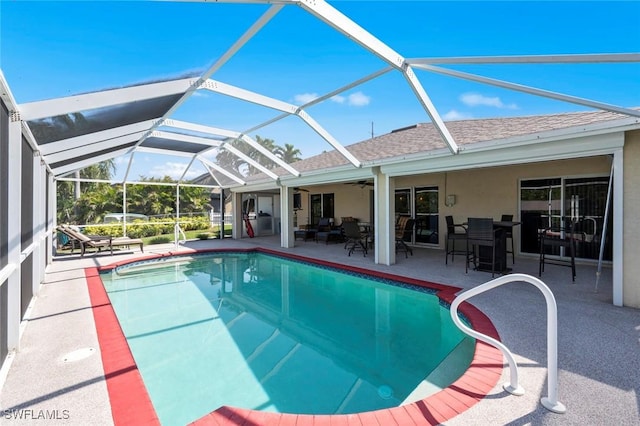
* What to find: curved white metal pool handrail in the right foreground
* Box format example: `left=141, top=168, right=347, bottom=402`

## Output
left=450, top=274, right=567, bottom=414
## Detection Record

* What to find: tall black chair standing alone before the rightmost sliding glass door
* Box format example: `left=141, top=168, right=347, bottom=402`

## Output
left=538, top=218, right=580, bottom=282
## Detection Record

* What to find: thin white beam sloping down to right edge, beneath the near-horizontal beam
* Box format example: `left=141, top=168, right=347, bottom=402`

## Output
left=415, top=64, right=640, bottom=117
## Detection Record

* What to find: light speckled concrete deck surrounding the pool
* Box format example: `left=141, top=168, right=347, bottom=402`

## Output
left=0, top=237, right=640, bottom=425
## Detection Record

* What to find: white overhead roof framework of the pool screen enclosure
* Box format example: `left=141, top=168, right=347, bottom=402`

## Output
left=6, top=0, right=640, bottom=187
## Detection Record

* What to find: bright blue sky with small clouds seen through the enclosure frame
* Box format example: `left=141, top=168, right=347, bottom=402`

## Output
left=0, top=0, right=640, bottom=178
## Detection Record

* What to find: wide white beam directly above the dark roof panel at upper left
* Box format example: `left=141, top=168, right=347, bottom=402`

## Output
left=20, top=78, right=197, bottom=121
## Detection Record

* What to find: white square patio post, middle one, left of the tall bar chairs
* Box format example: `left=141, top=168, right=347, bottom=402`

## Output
left=373, top=168, right=396, bottom=265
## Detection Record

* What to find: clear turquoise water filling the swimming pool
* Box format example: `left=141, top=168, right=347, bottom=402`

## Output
left=101, top=253, right=473, bottom=425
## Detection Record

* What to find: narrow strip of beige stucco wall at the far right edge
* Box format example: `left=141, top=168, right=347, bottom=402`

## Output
left=622, top=130, right=640, bottom=308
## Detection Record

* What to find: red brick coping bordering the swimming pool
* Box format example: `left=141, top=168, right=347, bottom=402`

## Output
left=85, top=248, right=503, bottom=426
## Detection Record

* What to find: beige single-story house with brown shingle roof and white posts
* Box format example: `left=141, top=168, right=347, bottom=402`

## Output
left=225, top=112, right=640, bottom=308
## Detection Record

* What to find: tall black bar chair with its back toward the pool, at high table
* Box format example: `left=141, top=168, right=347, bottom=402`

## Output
left=465, top=217, right=505, bottom=278
